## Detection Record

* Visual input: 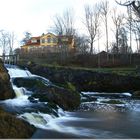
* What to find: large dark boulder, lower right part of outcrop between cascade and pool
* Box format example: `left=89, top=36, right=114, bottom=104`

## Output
left=32, top=86, right=80, bottom=110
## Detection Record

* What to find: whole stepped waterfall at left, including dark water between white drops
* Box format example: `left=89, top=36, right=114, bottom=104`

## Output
left=4, top=65, right=64, bottom=129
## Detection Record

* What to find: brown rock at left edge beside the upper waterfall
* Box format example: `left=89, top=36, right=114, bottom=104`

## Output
left=0, top=60, right=15, bottom=100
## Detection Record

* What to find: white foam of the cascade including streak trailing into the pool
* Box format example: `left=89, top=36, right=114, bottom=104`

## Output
left=6, top=66, right=93, bottom=136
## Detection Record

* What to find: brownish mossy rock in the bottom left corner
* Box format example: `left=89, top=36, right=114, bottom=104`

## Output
left=0, top=108, right=36, bottom=139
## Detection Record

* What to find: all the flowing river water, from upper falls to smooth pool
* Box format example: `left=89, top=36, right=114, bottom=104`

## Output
left=0, top=66, right=140, bottom=138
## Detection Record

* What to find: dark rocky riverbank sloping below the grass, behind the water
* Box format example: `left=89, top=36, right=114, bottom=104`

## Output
left=19, top=63, right=140, bottom=93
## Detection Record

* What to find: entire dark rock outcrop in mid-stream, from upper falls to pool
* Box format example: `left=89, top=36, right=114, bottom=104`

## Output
left=13, top=77, right=80, bottom=110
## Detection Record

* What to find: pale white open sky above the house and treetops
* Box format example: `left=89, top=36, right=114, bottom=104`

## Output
left=0, top=0, right=127, bottom=53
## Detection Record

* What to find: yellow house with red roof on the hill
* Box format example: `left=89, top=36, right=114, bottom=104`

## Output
left=21, top=33, right=74, bottom=52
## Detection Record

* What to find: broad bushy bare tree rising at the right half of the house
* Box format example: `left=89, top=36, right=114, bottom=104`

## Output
left=52, top=9, right=75, bottom=62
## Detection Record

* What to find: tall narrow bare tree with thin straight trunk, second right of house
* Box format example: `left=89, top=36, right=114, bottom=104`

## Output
left=101, top=1, right=109, bottom=57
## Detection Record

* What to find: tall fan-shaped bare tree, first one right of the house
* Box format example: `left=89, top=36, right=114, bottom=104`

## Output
left=85, top=4, right=100, bottom=54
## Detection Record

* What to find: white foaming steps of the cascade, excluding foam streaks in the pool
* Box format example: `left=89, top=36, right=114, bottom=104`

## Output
left=4, top=65, right=64, bottom=129
